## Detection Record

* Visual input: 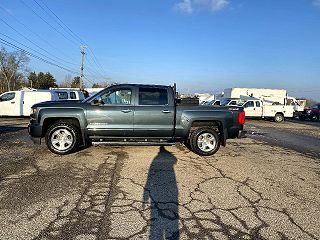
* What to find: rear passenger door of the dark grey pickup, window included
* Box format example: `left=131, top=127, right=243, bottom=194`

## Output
left=134, top=86, right=175, bottom=138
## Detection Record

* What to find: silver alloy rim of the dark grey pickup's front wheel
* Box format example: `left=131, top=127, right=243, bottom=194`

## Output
left=51, top=129, right=74, bottom=151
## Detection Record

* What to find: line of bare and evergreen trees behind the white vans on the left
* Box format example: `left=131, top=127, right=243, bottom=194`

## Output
left=0, top=47, right=114, bottom=94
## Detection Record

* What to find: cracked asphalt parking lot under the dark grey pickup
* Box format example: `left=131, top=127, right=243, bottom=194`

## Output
left=0, top=118, right=320, bottom=239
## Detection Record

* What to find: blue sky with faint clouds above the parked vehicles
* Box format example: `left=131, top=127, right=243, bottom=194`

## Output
left=0, top=0, right=320, bottom=100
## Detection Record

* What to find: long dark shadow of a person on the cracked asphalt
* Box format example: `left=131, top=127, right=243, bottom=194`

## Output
left=143, top=146, right=179, bottom=240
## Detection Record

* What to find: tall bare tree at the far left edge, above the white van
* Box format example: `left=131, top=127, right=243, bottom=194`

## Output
left=0, top=47, right=29, bottom=92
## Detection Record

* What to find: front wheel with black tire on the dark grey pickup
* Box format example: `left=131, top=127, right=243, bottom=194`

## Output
left=45, top=122, right=80, bottom=155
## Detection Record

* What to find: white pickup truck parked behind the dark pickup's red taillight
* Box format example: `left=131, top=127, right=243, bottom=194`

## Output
left=241, top=100, right=294, bottom=122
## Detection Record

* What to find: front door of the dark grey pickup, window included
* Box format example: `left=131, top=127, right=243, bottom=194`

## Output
left=87, top=88, right=134, bottom=138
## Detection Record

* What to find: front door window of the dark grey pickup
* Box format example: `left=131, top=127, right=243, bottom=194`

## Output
left=101, top=89, right=132, bottom=105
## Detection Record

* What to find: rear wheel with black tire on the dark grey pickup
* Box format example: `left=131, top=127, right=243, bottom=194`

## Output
left=189, top=127, right=220, bottom=156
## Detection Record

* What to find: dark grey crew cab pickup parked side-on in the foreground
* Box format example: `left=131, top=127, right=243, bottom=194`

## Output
left=28, top=84, right=245, bottom=156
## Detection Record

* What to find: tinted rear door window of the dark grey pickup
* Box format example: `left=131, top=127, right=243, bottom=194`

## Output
left=139, top=88, right=168, bottom=105
